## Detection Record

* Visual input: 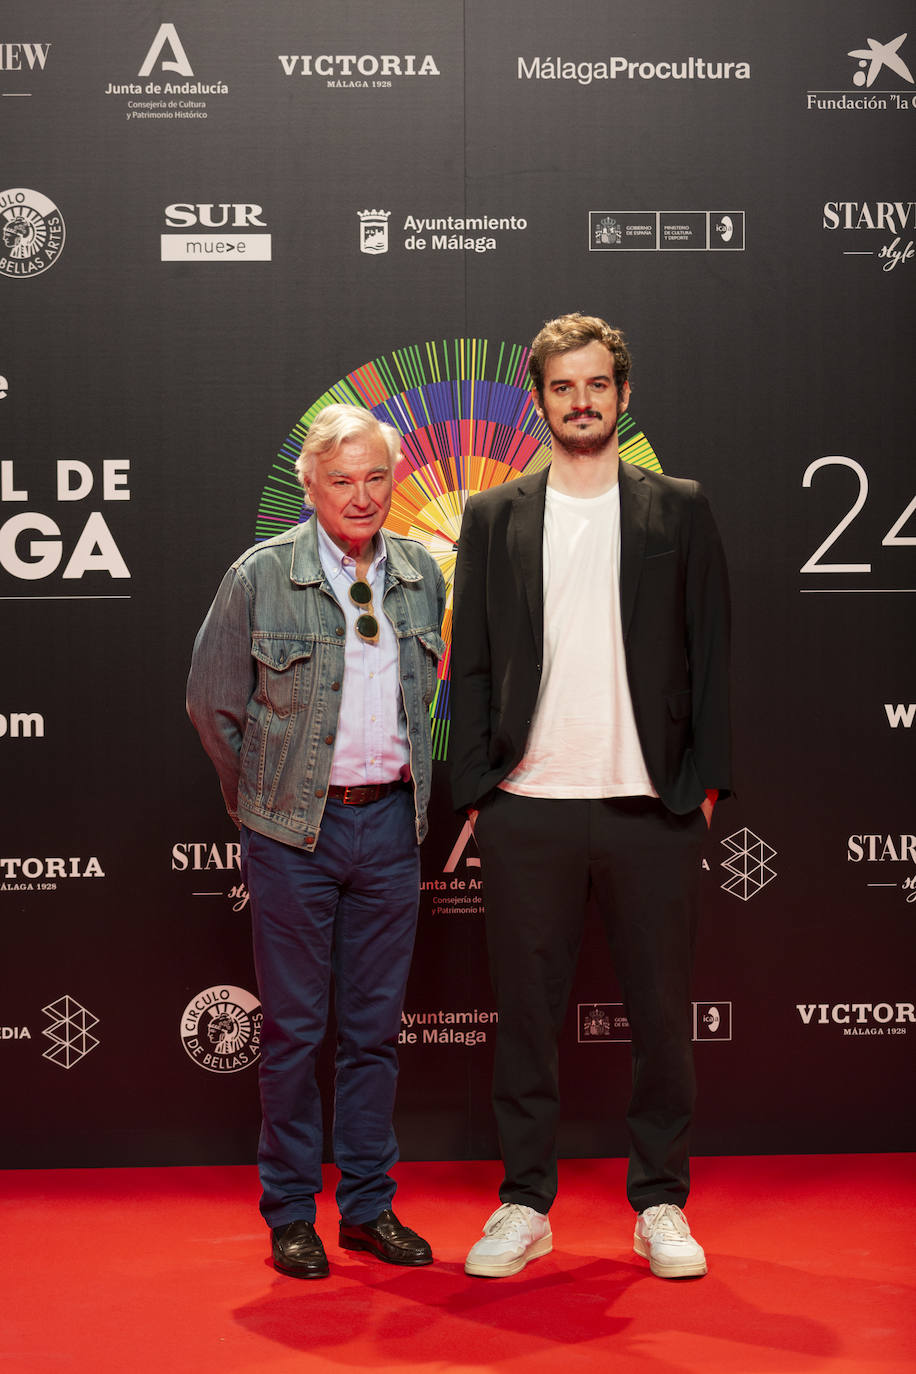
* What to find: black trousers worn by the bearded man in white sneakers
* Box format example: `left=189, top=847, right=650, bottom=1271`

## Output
left=475, top=790, right=706, bottom=1212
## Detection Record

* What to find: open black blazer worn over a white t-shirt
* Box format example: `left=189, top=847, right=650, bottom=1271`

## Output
left=449, top=462, right=731, bottom=813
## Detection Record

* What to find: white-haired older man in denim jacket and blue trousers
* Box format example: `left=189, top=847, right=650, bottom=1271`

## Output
left=188, top=405, right=445, bottom=1279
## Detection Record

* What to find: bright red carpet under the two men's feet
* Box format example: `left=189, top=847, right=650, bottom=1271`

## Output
left=0, top=1154, right=916, bottom=1374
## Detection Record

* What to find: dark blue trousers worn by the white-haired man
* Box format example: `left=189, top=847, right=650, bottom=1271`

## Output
left=242, top=789, right=420, bottom=1227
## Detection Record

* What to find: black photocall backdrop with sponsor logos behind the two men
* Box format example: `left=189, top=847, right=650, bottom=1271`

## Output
left=0, top=0, right=916, bottom=1167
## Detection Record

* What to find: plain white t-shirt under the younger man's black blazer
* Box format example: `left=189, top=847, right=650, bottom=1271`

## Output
left=500, top=486, right=658, bottom=797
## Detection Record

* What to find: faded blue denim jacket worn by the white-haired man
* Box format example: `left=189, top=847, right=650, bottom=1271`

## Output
left=187, top=518, right=445, bottom=851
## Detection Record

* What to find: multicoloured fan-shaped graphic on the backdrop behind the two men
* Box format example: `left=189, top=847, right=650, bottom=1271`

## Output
left=255, top=339, right=662, bottom=760
